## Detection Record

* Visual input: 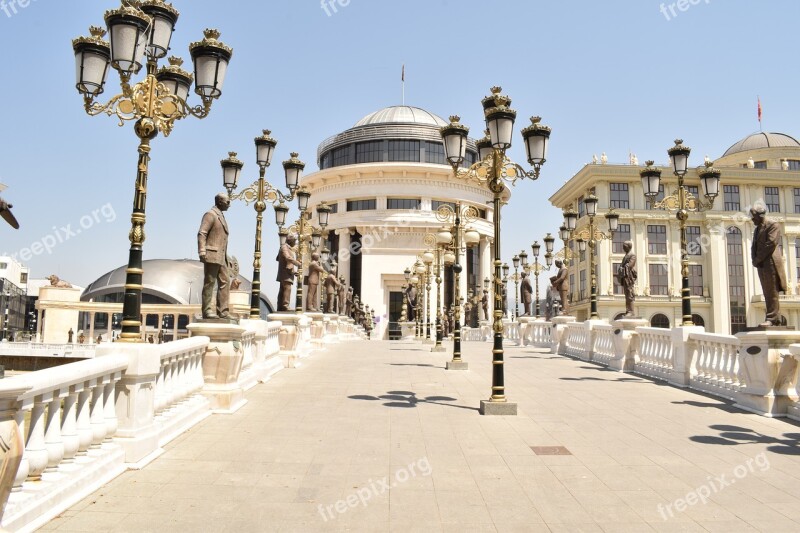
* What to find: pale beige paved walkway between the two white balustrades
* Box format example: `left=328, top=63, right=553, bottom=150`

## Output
left=44, top=341, right=800, bottom=533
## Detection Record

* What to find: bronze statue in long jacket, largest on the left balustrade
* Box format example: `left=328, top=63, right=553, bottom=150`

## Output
left=197, top=193, right=231, bottom=319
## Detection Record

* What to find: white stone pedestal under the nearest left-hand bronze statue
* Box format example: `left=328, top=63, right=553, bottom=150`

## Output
left=186, top=321, right=247, bottom=413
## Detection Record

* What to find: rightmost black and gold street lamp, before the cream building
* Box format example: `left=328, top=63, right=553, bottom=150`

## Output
left=639, top=139, right=721, bottom=326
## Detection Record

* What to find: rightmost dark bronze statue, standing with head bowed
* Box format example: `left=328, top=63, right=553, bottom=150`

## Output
left=750, top=205, right=787, bottom=327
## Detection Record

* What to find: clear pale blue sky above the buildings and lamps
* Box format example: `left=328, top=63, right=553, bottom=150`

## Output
left=0, top=0, right=800, bottom=298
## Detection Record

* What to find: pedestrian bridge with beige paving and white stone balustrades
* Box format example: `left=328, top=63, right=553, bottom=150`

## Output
left=0, top=317, right=800, bottom=531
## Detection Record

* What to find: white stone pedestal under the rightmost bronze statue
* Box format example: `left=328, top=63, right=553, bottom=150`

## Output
left=736, top=329, right=800, bottom=417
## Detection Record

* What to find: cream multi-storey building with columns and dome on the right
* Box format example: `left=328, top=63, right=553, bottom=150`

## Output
left=550, top=133, right=800, bottom=333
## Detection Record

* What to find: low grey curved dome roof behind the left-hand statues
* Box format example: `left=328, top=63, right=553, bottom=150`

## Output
left=81, top=259, right=274, bottom=311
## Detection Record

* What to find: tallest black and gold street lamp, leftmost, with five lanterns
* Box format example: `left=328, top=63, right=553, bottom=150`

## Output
left=72, top=0, right=233, bottom=342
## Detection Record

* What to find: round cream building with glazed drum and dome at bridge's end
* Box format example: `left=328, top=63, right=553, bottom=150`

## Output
left=302, top=106, right=494, bottom=338
